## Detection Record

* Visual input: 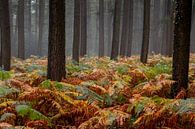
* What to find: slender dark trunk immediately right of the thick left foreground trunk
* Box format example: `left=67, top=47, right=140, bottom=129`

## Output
left=72, top=0, right=81, bottom=63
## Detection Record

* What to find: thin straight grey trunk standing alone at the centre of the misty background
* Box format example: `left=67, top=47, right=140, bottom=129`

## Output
left=99, top=0, right=104, bottom=57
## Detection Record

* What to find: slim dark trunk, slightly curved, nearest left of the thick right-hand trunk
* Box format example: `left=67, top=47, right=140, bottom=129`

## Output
left=141, top=0, right=150, bottom=63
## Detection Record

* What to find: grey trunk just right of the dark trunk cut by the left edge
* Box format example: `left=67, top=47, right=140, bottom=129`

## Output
left=18, top=0, right=25, bottom=59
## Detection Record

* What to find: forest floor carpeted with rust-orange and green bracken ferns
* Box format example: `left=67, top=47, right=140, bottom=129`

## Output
left=0, top=55, right=195, bottom=129
